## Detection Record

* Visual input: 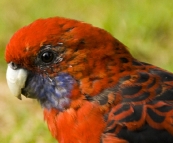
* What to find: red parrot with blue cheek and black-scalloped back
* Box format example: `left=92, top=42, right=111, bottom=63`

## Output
left=5, top=17, right=173, bottom=143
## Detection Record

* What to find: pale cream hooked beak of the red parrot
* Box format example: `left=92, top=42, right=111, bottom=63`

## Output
left=6, top=63, right=28, bottom=99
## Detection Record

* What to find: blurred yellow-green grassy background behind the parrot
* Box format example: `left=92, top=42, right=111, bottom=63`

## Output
left=0, top=0, right=173, bottom=143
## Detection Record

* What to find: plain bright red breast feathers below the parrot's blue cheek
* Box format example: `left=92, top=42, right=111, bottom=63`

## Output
left=44, top=101, right=105, bottom=143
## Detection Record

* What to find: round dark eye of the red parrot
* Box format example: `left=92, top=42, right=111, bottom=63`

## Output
left=40, top=51, right=55, bottom=63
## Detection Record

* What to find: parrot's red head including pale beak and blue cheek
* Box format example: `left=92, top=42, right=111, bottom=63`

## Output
left=5, top=17, right=132, bottom=110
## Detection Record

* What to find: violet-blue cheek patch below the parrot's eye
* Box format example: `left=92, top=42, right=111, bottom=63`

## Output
left=25, top=73, right=76, bottom=111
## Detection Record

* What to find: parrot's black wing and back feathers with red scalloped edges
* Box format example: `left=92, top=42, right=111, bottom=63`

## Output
left=104, top=62, right=173, bottom=143
